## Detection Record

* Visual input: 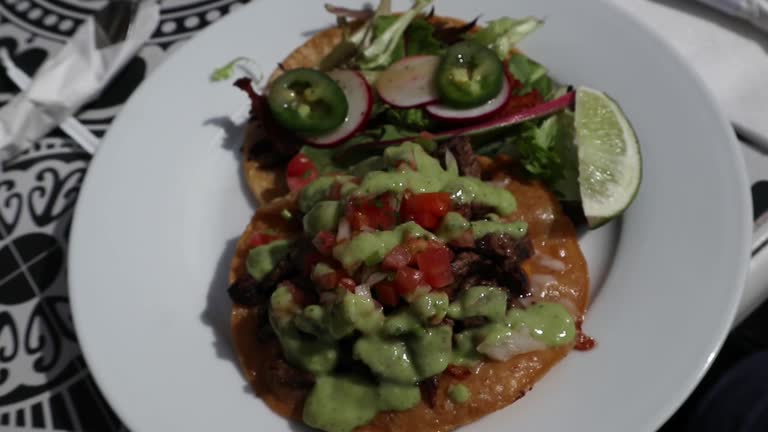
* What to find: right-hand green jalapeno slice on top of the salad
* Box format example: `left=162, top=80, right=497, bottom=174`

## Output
left=435, top=41, right=504, bottom=108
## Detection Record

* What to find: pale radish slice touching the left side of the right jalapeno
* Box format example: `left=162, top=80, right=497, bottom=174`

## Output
left=376, top=55, right=440, bottom=108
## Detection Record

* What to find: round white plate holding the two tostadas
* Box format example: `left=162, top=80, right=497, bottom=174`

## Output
left=70, top=0, right=750, bottom=432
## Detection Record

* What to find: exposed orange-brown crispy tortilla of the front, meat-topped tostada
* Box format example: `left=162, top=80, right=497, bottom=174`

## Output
left=230, top=160, right=589, bottom=432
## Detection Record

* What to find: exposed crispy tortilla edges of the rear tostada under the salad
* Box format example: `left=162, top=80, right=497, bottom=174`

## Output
left=242, top=17, right=476, bottom=204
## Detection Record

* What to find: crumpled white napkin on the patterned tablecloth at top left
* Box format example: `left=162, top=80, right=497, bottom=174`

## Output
left=0, top=0, right=160, bottom=161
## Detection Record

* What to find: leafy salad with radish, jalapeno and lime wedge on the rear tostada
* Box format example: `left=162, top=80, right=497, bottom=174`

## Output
left=224, top=0, right=641, bottom=226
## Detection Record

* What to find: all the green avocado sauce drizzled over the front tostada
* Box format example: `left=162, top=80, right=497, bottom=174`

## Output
left=268, top=142, right=575, bottom=432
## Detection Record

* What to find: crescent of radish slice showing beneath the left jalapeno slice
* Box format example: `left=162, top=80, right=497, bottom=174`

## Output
left=304, top=69, right=373, bottom=147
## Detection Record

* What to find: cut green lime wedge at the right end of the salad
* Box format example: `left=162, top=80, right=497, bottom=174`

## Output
left=575, top=87, right=642, bottom=228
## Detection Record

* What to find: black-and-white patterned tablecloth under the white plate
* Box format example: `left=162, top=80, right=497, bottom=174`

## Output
left=0, top=0, right=768, bottom=431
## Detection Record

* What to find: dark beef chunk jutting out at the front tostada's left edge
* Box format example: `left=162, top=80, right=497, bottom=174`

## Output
left=227, top=249, right=298, bottom=306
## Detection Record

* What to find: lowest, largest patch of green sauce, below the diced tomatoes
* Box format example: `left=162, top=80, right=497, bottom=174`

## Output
left=269, top=285, right=575, bottom=432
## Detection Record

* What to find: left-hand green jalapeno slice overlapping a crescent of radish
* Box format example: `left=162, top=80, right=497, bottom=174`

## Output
left=267, top=68, right=349, bottom=134
